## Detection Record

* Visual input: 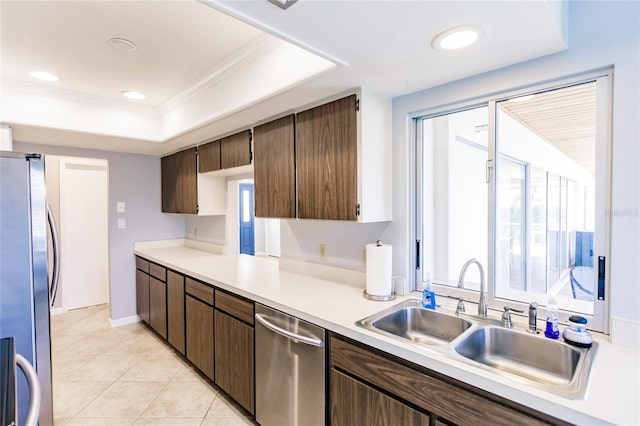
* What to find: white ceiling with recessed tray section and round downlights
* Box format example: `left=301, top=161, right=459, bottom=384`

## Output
left=0, top=0, right=567, bottom=154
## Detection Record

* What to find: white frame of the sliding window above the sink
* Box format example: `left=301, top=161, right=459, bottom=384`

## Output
left=409, top=69, right=613, bottom=334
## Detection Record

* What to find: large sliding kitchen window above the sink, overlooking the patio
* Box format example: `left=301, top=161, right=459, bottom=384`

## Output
left=415, top=74, right=611, bottom=332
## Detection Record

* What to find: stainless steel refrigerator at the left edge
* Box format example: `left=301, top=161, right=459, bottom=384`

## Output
left=0, top=152, right=53, bottom=426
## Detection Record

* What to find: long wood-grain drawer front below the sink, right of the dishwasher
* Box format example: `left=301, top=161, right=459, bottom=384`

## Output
left=330, top=336, right=548, bottom=425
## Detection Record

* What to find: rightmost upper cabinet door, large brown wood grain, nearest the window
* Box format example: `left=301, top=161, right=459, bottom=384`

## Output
left=296, top=95, right=358, bottom=220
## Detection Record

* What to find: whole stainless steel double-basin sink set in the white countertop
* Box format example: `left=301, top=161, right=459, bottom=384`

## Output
left=356, top=299, right=598, bottom=399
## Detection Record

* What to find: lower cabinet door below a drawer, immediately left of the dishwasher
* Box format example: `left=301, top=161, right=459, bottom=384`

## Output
left=215, top=309, right=255, bottom=414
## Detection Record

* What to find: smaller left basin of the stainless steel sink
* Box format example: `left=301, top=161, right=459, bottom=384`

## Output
left=356, top=300, right=472, bottom=346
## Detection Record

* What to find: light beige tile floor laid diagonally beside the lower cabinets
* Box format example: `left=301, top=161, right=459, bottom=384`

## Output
left=51, top=305, right=256, bottom=426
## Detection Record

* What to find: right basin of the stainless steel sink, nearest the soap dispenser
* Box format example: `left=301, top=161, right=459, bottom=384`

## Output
left=455, top=327, right=597, bottom=397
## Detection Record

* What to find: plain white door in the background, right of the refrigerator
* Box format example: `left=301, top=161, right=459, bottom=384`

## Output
left=59, top=157, right=109, bottom=309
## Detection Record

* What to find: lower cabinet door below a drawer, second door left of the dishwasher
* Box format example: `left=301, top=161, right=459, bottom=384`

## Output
left=185, top=296, right=214, bottom=380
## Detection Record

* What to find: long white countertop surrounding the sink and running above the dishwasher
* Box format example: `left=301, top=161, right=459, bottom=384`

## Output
left=135, top=242, right=640, bottom=425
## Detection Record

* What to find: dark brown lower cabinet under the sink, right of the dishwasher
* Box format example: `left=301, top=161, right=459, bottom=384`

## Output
left=329, top=334, right=564, bottom=426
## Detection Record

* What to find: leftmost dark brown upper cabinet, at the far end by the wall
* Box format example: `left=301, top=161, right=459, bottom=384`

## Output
left=161, top=148, right=198, bottom=214
